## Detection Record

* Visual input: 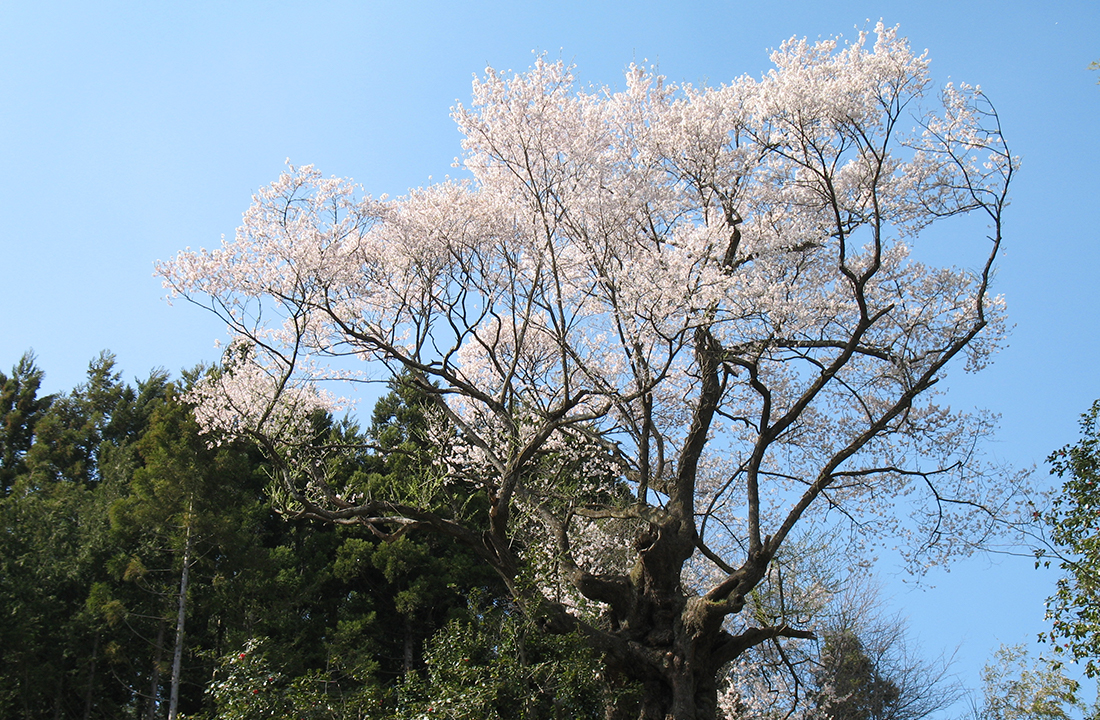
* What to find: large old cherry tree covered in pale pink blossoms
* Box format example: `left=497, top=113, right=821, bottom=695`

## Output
left=158, top=24, right=1018, bottom=720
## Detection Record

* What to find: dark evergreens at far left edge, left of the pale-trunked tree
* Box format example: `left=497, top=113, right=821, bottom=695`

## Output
left=0, top=354, right=160, bottom=719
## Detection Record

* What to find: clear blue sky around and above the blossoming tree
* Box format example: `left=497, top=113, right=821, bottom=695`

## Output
left=0, top=0, right=1100, bottom=707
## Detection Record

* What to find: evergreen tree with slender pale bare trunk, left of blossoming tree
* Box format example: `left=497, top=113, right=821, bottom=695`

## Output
left=111, top=384, right=264, bottom=718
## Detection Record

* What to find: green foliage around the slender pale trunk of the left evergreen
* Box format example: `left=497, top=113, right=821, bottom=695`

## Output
left=103, top=383, right=266, bottom=711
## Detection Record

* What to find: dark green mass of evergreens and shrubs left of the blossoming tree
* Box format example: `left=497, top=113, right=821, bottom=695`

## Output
left=0, top=353, right=602, bottom=720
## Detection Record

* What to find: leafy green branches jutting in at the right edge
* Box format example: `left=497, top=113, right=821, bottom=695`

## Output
left=1036, top=401, right=1100, bottom=677
